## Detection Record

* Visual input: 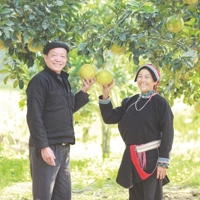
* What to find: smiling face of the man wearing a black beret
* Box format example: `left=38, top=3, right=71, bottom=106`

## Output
left=44, top=48, right=67, bottom=74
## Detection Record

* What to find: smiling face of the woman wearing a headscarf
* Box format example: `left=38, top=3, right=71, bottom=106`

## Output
left=137, top=69, right=156, bottom=94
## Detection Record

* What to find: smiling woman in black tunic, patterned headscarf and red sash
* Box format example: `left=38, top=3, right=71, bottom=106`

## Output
left=99, top=64, right=174, bottom=200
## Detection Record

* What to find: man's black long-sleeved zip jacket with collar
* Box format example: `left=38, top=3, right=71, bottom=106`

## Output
left=26, top=67, right=89, bottom=149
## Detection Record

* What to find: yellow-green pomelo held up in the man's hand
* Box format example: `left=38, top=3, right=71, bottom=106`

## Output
left=78, top=64, right=96, bottom=79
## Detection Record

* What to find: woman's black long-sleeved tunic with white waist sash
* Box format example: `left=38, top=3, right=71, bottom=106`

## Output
left=99, top=95, right=174, bottom=188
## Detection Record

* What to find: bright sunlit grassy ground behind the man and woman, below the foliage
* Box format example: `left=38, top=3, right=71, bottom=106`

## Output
left=0, top=91, right=200, bottom=200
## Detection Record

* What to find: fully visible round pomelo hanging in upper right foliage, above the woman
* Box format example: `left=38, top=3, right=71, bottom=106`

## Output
left=166, top=15, right=184, bottom=33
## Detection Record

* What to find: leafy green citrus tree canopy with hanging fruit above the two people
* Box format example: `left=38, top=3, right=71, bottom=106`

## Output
left=0, top=0, right=200, bottom=155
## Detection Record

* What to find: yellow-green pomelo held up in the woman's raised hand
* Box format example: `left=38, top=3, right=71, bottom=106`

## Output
left=96, top=69, right=113, bottom=85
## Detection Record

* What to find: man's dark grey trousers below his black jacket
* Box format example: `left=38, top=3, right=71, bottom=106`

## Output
left=29, top=144, right=71, bottom=200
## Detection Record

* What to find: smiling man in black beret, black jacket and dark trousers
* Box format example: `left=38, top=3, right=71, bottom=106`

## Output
left=26, top=41, right=95, bottom=200
